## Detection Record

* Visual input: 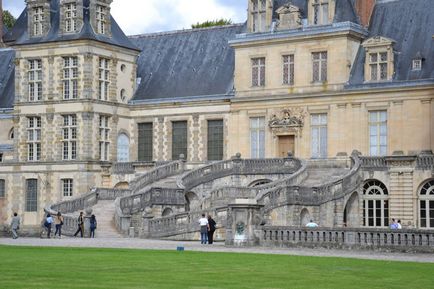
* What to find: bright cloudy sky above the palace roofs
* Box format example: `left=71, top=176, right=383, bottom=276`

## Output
left=3, top=0, right=247, bottom=35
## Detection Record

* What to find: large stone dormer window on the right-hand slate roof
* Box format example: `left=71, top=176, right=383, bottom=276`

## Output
left=362, top=36, right=394, bottom=82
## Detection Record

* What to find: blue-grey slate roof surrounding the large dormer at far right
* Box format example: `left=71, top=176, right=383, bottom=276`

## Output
left=350, top=0, right=434, bottom=86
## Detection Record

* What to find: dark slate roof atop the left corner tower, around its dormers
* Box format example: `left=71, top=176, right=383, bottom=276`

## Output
left=3, top=0, right=137, bottom=50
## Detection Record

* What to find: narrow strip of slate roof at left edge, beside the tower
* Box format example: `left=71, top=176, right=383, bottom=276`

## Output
left=0, top=49, right=15, bottom=108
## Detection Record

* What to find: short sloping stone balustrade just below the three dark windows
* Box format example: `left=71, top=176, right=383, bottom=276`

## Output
left=130, top=159, right=185, bottom=194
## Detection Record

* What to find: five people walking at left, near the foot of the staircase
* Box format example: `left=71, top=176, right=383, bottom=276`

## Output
left=11, top=212, right=97, bottom=239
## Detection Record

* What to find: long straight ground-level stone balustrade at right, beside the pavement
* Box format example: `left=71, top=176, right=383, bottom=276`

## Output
left=257, top=226, right=434, bottom=252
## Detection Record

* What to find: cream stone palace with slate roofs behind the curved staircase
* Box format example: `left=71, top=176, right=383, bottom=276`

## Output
left=0, top=0, right=434, bottom=237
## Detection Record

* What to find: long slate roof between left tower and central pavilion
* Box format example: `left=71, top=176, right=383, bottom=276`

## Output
left=130, top=24, right=245, bottom=101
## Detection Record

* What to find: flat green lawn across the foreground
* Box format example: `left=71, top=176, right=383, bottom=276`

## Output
left=0, top=246, right=434, bottom=289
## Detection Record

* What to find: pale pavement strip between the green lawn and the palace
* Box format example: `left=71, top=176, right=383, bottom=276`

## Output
left=0, top=237, right=434, bottom=263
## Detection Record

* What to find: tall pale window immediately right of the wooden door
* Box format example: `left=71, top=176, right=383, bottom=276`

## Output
left=311, top=113, right=327, bottom=158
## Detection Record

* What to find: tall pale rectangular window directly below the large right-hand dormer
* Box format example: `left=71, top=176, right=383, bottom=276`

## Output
left=369, top=111, right=387, bottom=156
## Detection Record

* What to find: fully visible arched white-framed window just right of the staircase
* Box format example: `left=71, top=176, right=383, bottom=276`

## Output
left=363, top=180, right=389, bottom=227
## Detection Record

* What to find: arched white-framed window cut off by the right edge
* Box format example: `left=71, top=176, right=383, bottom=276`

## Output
left=419, top=180, right=434, bottom=229
